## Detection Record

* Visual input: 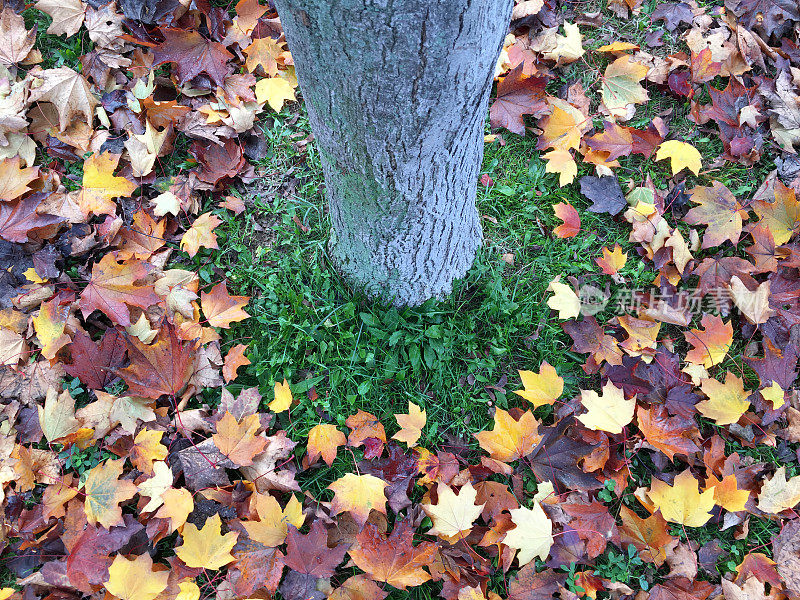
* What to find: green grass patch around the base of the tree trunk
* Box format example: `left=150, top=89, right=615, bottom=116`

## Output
left=220, top=109, right=651, bottom=443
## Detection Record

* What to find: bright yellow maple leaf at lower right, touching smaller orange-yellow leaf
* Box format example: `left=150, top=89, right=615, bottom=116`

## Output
left=647, top=469, right=715, bottom=527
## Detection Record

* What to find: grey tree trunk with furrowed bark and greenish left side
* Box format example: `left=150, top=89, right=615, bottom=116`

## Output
left=275, top=0, right=512, bottom=306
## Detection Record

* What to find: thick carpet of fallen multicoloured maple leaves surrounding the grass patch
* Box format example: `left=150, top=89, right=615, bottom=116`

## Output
left=0, top=0, right=800, bottom=600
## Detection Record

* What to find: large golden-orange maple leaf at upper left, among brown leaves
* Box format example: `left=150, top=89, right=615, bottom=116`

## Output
left=78, top=152, right=139, bottom=216
